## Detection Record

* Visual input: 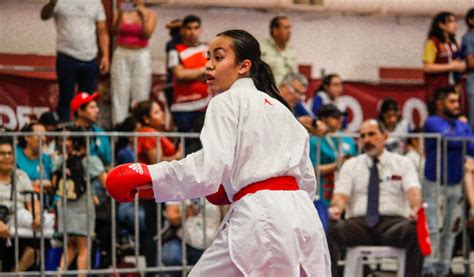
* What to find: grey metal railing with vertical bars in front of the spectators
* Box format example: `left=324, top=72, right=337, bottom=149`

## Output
left=2, top=132, right=474, bottom=276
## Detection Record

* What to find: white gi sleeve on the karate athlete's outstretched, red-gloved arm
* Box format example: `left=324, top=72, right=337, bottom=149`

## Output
left=148, top=94, right=239, bottom=202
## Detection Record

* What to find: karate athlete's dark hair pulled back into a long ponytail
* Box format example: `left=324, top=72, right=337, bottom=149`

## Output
left=217, top=30, right=291, bottom=110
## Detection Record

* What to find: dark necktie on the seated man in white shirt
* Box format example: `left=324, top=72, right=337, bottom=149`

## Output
left=365, top=159, right=380, bottom=227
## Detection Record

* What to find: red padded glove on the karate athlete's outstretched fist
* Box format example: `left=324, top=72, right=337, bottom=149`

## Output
left=105, top=163, right=154, bottom=202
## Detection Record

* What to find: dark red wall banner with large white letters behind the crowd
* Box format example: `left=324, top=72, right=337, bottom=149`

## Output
left=0, top=72, right=427, bottom=131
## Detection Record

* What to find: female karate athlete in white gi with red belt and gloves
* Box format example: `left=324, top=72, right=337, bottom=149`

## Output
left=107, top=30, right=331, bottom=276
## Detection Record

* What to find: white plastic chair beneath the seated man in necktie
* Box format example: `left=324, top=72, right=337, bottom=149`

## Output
left=344, top=246, right=406, bottom=277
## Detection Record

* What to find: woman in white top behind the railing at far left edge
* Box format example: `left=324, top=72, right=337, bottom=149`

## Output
left=0, top=137, right=41, bottom=272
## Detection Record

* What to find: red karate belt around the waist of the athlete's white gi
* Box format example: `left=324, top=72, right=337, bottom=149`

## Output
left=206, top=176, right=299, bottom=206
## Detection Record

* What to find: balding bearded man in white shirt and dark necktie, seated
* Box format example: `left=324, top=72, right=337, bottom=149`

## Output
left=328, top=119, right=423, bottom=276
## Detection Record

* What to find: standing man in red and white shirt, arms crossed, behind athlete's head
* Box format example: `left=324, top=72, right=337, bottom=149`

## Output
left=168, top=15, right=211, bottom=153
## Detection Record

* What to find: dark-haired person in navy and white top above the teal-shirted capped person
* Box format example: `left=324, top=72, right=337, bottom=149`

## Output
left=306, top=74, right=347, bottom=128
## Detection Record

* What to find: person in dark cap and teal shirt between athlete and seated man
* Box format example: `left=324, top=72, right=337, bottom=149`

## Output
left=309, top=104, right=357, bottom=207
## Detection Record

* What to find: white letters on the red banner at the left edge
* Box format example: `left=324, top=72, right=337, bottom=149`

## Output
left=0, top=105, right=49, bottom=130
